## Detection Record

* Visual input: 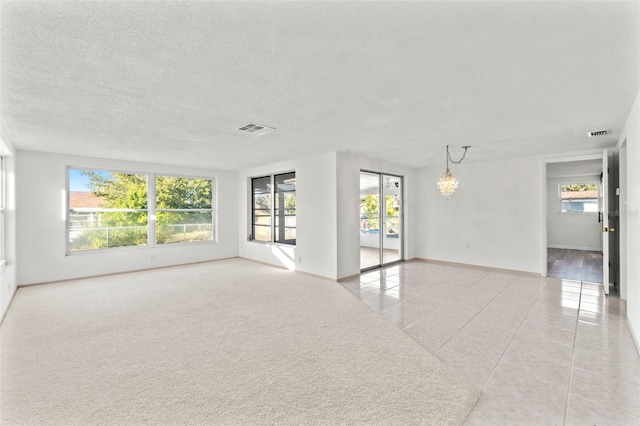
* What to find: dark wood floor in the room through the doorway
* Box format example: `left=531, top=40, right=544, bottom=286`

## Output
left=547, top=248, right=602, bottom=284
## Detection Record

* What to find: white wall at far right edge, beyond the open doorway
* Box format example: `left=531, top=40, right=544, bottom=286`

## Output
left=618, top=92, right=640, bottom=350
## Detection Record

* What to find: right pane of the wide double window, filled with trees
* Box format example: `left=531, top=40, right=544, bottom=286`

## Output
left=156, top=176, right=214, bottom=244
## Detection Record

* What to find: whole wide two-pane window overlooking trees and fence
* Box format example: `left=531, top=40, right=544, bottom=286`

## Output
left=67, top=168, right=215, bottom=253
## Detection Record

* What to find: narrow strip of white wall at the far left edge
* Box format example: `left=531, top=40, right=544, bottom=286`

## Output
left=0, top=127, right=17, bottom=321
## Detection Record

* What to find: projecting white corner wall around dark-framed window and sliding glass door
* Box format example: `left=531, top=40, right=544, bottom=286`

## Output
left=239, top=152, right=416, bottom=279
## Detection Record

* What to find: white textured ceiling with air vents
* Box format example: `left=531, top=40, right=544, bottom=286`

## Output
left=0, top=1, right=640, bottom=169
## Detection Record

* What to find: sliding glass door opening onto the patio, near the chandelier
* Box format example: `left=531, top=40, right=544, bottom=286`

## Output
left=360, top=170, right=403, bottom=271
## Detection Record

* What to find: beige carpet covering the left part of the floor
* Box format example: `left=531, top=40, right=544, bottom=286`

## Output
left=0, top=259, right=479, bottom=425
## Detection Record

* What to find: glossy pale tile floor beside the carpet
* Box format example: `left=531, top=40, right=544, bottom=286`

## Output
left=341, top=262, right=640, bottom=426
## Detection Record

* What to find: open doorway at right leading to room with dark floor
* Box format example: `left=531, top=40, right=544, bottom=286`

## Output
left=545, top=155, right=619, bottom=294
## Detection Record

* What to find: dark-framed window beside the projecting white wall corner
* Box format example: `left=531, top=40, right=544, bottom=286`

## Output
left=251, top=172, right=296, bottom=245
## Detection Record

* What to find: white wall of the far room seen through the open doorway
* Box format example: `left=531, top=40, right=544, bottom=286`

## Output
left=547, top=175, right=602, bottom=251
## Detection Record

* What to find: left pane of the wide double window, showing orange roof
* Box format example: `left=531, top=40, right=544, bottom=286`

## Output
left=68, top=169, right=149, bottom=252
